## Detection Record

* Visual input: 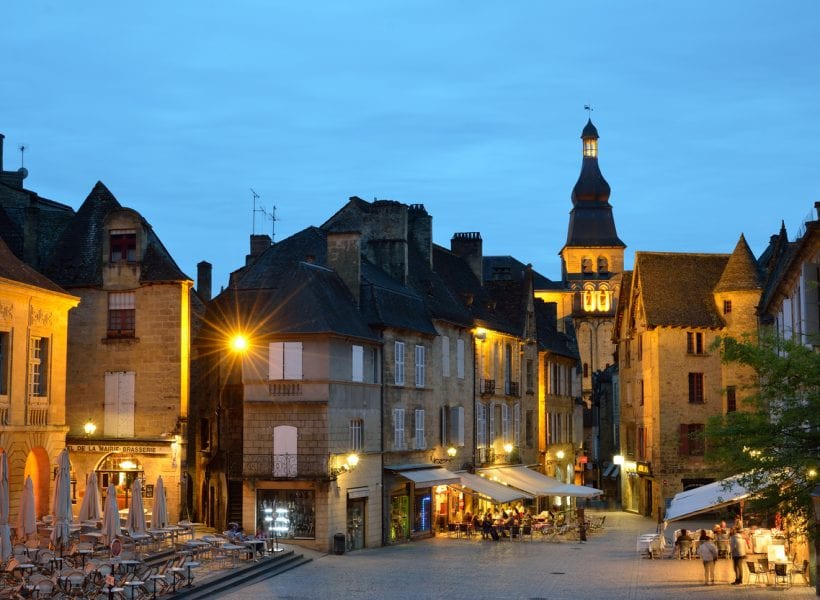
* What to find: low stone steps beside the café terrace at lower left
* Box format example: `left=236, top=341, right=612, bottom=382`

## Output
left=166, top=550, right=312, bottom=600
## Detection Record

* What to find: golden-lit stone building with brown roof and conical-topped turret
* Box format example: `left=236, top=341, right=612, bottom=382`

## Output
left=616, top=236, right=762, bottom=517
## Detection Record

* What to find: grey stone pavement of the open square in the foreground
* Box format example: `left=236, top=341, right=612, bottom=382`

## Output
left=220, top=511, right=815, bottom=600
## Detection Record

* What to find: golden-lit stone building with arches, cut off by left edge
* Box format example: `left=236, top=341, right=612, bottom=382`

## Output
left=0, top=236, right=79, bottom=518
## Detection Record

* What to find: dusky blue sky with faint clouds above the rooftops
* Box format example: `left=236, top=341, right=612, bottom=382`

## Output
left=0, top=0, right=820, bottom=290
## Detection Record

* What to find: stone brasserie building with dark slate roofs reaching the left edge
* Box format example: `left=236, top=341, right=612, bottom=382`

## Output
left=0, top=144, right=192, bottom=520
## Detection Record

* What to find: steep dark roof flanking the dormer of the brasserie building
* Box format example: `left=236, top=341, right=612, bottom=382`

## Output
left=44, top=181, right=190, bottom=287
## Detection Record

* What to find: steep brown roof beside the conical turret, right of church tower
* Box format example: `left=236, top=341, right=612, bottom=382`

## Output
left=633, top=252, right=729, bottom=327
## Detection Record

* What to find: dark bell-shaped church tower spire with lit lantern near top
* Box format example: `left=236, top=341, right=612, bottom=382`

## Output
left=566, top=119, right=626, bottom=247
